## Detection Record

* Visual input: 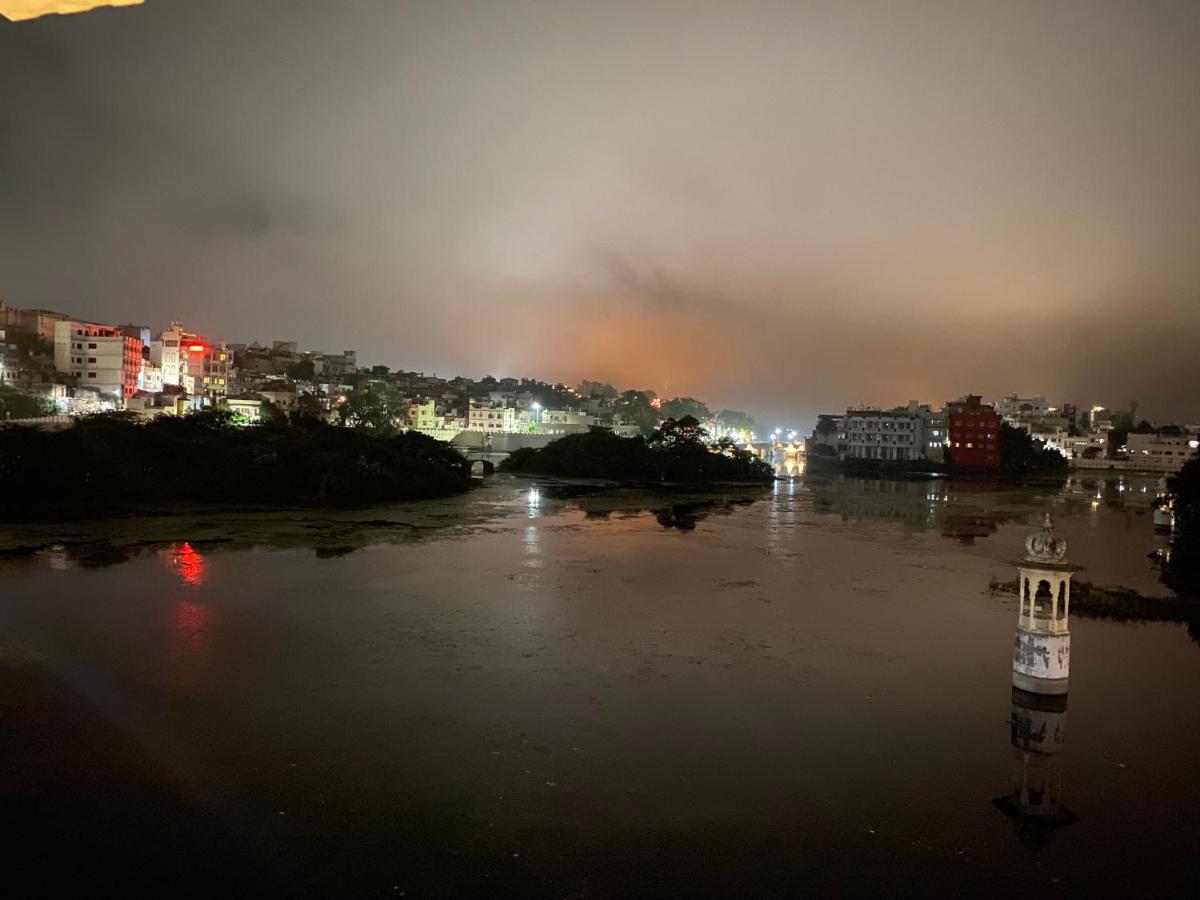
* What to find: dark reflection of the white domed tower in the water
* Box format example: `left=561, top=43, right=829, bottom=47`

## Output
left=992, top=688, right=1078, bottom=850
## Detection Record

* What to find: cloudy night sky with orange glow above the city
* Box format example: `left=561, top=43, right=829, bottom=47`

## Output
left=0, top=0, right=1200, bottom=424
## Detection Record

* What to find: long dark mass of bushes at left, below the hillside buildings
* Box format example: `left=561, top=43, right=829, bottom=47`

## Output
left=0, top=412, right=469, bottom=520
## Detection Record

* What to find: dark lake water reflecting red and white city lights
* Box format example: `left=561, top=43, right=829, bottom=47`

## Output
left=0, top=478, right=1200, bottom=896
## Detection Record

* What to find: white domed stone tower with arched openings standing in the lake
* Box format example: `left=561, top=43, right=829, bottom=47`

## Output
left=1013, top=512, right=1073, bottom=694
